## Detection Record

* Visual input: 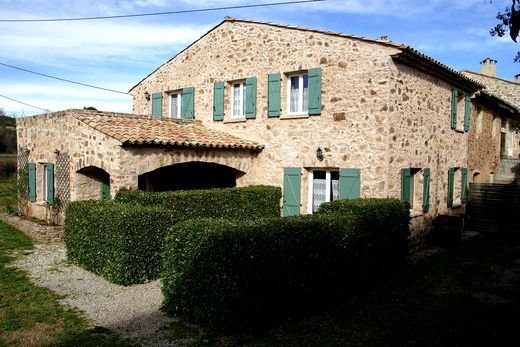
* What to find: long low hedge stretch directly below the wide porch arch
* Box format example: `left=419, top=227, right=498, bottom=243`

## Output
left=115, top=186, right=282, bottom=220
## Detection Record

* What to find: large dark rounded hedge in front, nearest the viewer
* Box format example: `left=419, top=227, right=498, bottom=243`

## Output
left=162, top=200, right=409, bottom=331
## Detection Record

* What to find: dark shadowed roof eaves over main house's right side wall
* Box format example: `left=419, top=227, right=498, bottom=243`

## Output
left=392, top=46, right=484, bottom=93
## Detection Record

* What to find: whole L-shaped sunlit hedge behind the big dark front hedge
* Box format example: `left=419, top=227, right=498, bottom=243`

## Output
left=64, top=186, right=281, bottom=285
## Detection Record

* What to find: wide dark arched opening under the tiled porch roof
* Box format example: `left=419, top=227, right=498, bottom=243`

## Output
left=138, top=161, right=244, bottom=192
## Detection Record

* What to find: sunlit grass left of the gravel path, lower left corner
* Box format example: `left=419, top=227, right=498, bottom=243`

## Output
left=0, top=222, right=136, bottom=346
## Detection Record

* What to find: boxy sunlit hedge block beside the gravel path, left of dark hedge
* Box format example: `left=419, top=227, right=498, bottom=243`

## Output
left=64, top=200, right=178, bottom=285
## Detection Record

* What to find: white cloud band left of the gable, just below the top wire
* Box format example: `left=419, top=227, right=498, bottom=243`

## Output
left=0, top=22, right=209, bottom=65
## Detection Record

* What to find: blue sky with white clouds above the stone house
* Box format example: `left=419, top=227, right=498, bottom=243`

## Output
left=0, top=0, right=520, bottom=116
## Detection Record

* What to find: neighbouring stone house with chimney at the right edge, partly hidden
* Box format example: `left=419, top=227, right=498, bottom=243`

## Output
left=463, top=58, right=520, bottom=183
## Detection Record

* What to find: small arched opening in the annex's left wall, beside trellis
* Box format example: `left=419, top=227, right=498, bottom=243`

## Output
left=74, top=166, right=110, bottom=200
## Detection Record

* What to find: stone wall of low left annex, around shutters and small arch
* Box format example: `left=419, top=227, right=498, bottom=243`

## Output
left=16, top=110, right=120, bottom=222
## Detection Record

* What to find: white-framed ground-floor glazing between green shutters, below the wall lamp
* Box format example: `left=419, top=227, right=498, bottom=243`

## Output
left=309, top=170, right=339, bottom=213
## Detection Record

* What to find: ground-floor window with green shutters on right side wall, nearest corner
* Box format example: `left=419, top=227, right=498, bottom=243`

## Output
left=401, top=168, right=430, bottom=213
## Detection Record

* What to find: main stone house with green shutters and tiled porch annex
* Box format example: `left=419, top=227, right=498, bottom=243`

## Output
left=18, top=18, right=482, bottom=243
